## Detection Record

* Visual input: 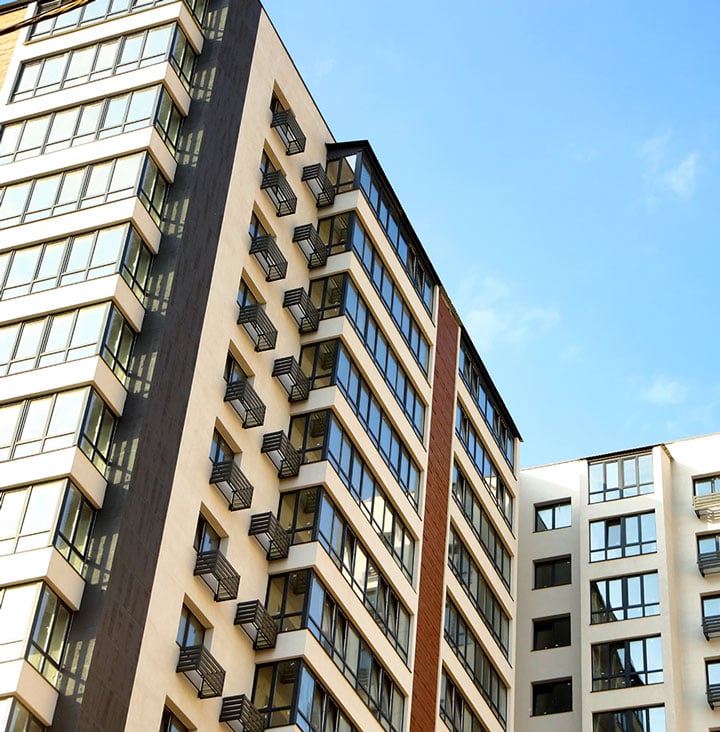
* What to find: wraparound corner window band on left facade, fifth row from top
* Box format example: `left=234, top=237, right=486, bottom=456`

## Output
left=0, top=224, right=152, bottom=300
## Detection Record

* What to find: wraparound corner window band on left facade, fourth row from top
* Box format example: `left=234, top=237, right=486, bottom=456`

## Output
left=0, top=153, right=169, bottom=229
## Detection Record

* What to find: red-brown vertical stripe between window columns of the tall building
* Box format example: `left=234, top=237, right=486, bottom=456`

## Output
left=410, top=293, right=460, bottom=732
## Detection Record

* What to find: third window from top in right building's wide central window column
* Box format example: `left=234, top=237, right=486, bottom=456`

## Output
left=590, top=572, right=660, bottom=623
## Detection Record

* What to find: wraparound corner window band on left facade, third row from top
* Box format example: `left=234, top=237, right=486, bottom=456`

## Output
left=0, top=86, right=182, bottom=164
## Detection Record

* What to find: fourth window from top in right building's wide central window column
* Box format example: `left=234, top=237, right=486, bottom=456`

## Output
left=592, top=635, right=663, bottom=691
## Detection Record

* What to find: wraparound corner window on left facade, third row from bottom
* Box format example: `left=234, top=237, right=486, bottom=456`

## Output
left=0, top=480, right=95, bottom=572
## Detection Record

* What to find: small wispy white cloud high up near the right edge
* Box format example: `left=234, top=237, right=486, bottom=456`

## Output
left=638, top=131, right=699, bottom=207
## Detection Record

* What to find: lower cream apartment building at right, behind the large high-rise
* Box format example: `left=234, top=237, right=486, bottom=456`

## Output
left=515, top=434, right=720, bottom=732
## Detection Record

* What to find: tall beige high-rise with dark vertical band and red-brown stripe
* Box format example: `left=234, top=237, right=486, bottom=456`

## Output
left=0, top=0, right=519, bottom=732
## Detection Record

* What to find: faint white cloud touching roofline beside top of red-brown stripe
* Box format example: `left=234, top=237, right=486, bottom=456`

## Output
left=463, top=277, right=560, bottom=352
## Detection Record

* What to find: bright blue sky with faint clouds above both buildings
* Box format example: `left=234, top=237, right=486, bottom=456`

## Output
left=264, top=0, right=720, bottom=467
